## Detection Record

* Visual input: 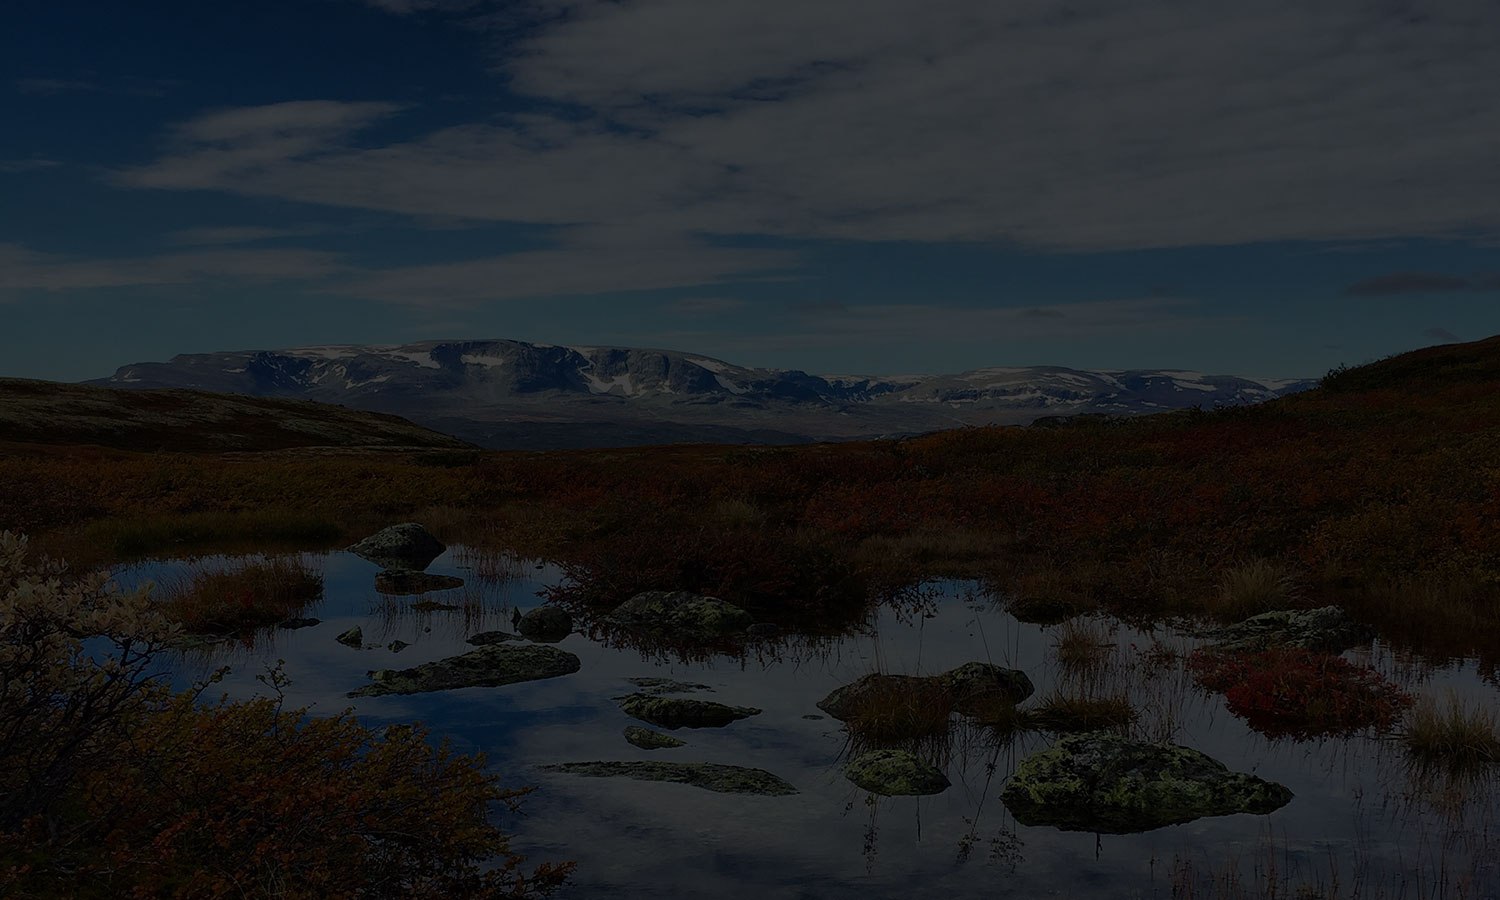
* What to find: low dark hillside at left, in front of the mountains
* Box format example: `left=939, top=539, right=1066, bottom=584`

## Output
left=0, top=378, right=471, bottom=453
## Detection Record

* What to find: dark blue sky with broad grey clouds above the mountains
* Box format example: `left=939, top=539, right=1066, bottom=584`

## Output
left=0, top=0, right=1500, bottom=381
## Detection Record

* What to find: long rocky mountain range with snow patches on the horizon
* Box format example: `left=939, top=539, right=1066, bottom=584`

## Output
left=90, top=341, right=1314, bottom=447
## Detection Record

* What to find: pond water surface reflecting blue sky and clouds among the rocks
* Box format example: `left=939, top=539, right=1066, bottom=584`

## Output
left=120, top=551, right=1500, bottom=897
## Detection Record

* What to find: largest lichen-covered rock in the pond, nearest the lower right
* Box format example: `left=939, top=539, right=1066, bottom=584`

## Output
left=1001, top=732, right=1292, bottom=834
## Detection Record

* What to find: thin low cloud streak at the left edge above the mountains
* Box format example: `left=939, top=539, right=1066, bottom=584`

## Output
left=0, top=245, right=348, bottom=299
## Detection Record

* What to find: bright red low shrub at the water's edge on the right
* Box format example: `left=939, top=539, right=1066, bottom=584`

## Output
left=1188, top=650, right=1412, bottom=738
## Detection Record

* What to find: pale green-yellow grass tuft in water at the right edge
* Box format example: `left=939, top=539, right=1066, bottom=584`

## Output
left=1401, top=690, right=1500, bottom=780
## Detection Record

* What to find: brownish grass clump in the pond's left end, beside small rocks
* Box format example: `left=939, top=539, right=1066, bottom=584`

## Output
left=156, top=557, right=323, bottom=635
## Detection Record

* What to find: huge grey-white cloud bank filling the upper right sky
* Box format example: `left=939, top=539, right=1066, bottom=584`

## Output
left=122, top=0, right=1500, bottom=251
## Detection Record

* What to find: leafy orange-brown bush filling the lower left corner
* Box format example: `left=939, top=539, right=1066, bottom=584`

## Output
left=0, top=533, right=570, bottom=900
